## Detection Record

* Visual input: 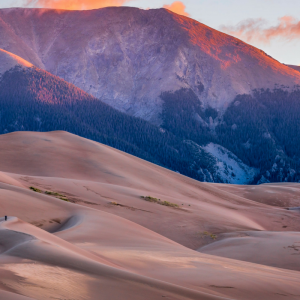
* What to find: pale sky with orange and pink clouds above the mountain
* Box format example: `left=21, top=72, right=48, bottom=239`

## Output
left=0, top=0, right=300, bottom=65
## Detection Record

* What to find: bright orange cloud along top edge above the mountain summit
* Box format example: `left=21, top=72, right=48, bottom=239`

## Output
left=26, top=0, right=131, bottom=10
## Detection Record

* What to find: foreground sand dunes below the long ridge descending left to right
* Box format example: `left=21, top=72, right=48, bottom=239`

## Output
left=0, top=184, right=300, bottom=299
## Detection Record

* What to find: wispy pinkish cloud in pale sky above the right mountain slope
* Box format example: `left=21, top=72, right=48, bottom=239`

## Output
left=221, top=16, right=300, bottom=44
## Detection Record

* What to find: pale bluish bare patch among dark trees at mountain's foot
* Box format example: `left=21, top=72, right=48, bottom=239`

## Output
left=201, top=143, right=259, bottom=184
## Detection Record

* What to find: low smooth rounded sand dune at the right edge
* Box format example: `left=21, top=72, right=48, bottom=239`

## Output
left=199, top=231, right=300, bottom=271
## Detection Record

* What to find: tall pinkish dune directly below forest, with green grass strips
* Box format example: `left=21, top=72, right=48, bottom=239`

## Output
left=0, top=132, right=300, bottom=249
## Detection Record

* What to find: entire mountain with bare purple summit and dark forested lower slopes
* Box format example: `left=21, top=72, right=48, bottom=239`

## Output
left=0, top=7, right=300, bottom=184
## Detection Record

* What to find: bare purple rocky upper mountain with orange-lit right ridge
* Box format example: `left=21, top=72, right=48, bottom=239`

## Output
left=0, top=7, right=300, bottom=123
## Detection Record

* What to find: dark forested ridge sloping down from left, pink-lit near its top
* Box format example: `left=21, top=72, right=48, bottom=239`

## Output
left=0, top=51, right=253, bottom=183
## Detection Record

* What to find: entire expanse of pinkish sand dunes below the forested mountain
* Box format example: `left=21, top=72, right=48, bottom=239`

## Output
left=0, top=132, right=300, bottom=300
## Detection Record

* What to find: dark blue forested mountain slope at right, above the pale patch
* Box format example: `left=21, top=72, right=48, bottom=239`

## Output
left=161, top=88, right=300, bottom=184
